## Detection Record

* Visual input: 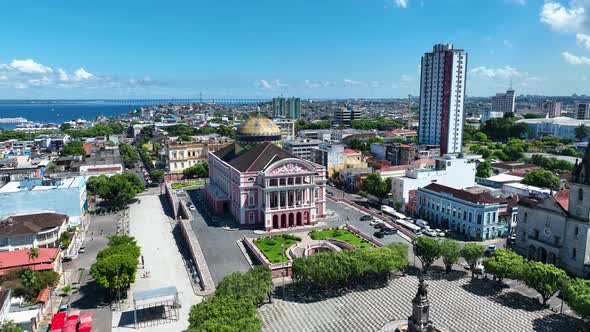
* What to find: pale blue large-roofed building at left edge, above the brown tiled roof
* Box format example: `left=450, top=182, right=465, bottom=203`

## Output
left=0, top=176, right=88, bottom=227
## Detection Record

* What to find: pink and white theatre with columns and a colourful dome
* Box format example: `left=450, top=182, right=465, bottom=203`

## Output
left=205, top=115, right=326, bottom=230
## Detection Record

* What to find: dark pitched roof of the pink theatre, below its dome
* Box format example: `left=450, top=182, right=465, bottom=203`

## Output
left=214, top=142, right=300, bottom=172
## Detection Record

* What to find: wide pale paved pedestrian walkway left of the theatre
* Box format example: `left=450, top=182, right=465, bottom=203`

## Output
left=113, top=195, right=202, bottom=332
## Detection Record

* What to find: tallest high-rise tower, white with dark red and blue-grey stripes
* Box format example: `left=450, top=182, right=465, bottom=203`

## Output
left=418, top=44, right=467, bottom=154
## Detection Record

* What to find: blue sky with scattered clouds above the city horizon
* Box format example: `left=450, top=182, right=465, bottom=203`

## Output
left=0, top=0, right=590, bottom=99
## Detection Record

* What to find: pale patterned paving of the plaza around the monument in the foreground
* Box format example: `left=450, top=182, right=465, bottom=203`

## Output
left=258, top=275, right=588, bottom=332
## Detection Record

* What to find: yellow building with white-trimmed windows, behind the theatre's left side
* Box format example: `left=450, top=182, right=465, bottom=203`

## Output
left=165, top=136, right=233, bottom=174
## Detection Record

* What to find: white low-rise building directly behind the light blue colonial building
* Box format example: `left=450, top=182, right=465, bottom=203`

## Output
left=391, top=156, right=476, bottom=209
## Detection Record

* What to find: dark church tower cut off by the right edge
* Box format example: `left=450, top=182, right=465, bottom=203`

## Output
left=568, top=142, right=590, bottom=221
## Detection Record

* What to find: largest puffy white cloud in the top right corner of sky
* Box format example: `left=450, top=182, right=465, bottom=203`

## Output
left=539, top=0, right=588, bottom=32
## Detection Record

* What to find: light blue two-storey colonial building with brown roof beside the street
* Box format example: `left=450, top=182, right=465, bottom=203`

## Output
left=416, top=183, right=516, bottom=241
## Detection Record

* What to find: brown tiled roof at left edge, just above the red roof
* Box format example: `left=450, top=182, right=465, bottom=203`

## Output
left=0, top=213, right=68, bottom=236
